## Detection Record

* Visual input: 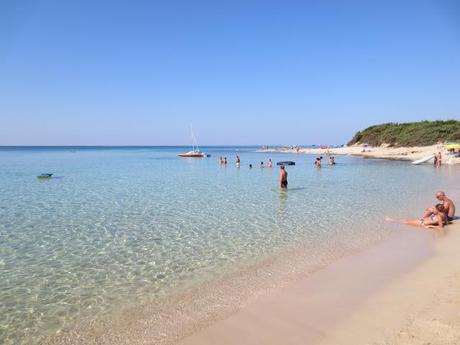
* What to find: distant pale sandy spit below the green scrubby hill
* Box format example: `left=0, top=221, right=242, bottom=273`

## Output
left=261, top=145, right=460, bottom=164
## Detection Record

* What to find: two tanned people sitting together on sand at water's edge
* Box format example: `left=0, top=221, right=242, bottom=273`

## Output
left=386, top=191, right=455, bottom=229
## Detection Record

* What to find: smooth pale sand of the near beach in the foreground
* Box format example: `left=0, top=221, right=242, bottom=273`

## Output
left=180, top=221, right=460, bottom=345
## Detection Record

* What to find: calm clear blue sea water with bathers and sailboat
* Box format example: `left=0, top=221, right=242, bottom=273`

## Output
left=0, top=147, right=460, bottom=344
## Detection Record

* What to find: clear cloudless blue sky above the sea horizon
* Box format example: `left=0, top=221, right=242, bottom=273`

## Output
left=0, top=0, right=460, bottom=145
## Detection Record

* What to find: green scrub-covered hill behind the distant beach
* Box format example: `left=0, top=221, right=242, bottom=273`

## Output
left=348, top=120, right=460, bottom=147
